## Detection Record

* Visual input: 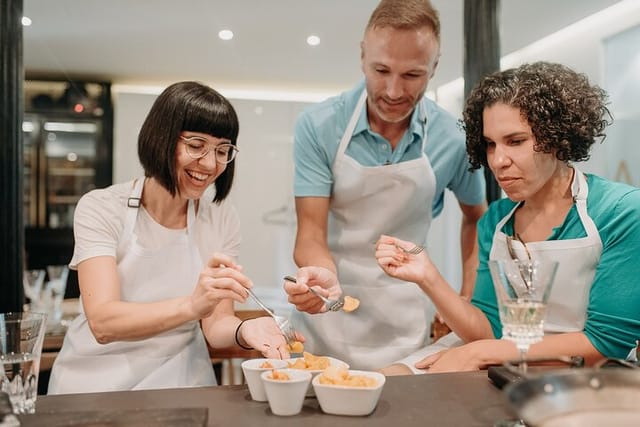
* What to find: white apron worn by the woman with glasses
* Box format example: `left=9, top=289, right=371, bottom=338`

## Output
left=49, top=178, right=216, bottom=394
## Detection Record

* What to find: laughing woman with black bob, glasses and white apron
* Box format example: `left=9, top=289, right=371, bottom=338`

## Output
left=49, top=82, right=296, bottom=394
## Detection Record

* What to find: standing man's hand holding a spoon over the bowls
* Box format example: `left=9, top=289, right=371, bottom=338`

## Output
left=284, top=266, right=342, bottom=314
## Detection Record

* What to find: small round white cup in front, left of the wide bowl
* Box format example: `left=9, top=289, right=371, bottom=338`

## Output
left=260, top=369, right=311, bottom=416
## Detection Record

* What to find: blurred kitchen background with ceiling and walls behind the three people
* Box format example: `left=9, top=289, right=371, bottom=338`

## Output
left=17, top=0, right=640, bottom=311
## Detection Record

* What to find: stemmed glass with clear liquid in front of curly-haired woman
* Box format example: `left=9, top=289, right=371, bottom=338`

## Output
left=489, top=259, right=558, bottom=373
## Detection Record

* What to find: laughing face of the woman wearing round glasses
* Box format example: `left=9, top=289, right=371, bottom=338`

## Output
left=176, top=132, right=229, bottom=199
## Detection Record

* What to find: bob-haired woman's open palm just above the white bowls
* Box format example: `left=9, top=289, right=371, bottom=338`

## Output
left=238, top=316, right=304, bottom=359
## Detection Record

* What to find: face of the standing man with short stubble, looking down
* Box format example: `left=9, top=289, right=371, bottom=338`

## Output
left=361, top=26, right=439, bottom=123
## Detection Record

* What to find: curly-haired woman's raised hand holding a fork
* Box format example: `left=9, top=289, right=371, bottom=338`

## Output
left=376, top=235, right=435, bottom=290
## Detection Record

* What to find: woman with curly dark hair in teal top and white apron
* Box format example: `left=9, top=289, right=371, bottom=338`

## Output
left=376, top=62, right=640, bottom=374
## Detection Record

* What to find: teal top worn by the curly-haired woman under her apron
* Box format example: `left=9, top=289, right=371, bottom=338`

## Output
left=472, top=174, right=640, bottom=358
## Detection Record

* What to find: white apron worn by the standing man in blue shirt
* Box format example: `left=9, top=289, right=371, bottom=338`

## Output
left=293, top=91, right=436, bottom=369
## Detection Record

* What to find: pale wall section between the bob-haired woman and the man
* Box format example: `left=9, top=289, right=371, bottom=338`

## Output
left=225, top=99, right=306, bottom=309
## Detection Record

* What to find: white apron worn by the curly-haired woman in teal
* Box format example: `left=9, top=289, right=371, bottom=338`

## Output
left=402, top=169, right=602, bottom=373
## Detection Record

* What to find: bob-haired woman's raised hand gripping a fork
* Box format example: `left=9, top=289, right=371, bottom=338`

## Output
left=190, top=253, right=253, bottom=319
